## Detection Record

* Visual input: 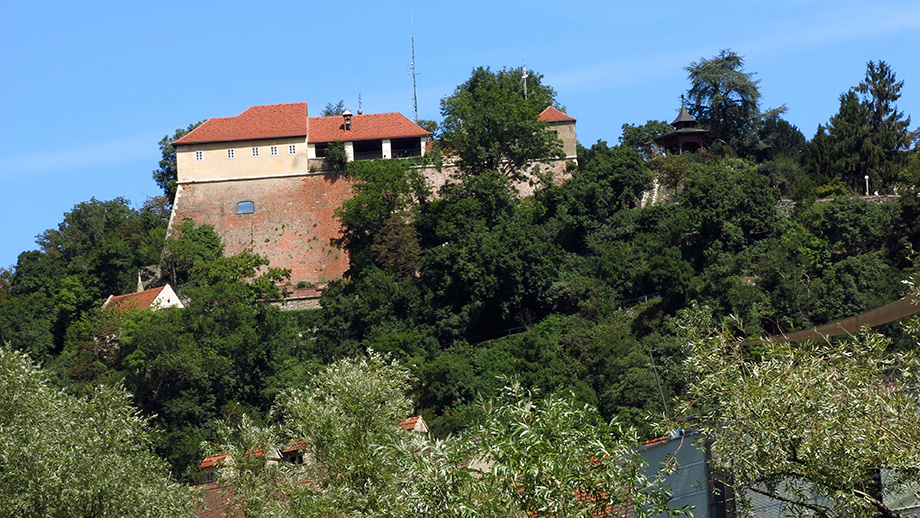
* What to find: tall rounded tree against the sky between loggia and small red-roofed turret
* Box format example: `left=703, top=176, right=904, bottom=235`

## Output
left=441, top=67, right=562, bottom=178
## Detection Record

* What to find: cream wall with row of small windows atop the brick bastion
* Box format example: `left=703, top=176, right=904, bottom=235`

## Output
left=176, top=137, right=308, bottom=183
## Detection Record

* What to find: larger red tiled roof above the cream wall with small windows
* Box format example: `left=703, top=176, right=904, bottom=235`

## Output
left=173, top=103, right=307, bottom=145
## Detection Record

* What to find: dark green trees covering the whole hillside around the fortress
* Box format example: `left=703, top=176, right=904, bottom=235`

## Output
left=0, top=51, right=920, bottom=516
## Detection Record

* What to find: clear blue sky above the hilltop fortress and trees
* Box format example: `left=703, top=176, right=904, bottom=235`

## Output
left=0, top=0, right=920, bottom=267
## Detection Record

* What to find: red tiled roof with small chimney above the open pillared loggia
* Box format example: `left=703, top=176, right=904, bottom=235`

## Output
left=308, top=112, right=429, bottom=142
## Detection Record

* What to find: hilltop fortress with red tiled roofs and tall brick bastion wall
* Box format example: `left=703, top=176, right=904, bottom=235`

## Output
left=170, top=102, right=576, bottom=284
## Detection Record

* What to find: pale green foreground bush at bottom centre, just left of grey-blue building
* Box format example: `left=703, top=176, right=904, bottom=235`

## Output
left=405, top=383, right=681, bottom=517
